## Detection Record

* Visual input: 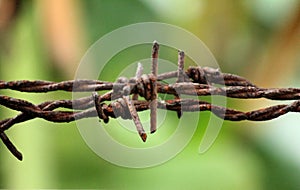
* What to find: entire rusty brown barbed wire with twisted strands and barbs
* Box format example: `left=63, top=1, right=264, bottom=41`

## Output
left=0, top=42, right=300, bottom=160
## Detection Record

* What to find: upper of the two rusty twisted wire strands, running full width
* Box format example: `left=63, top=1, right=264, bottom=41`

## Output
left=0, top=78, right=300, bottom=100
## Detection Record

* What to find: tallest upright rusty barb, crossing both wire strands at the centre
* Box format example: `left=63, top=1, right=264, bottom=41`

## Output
left=150, top=41, right=159, bottom=133
